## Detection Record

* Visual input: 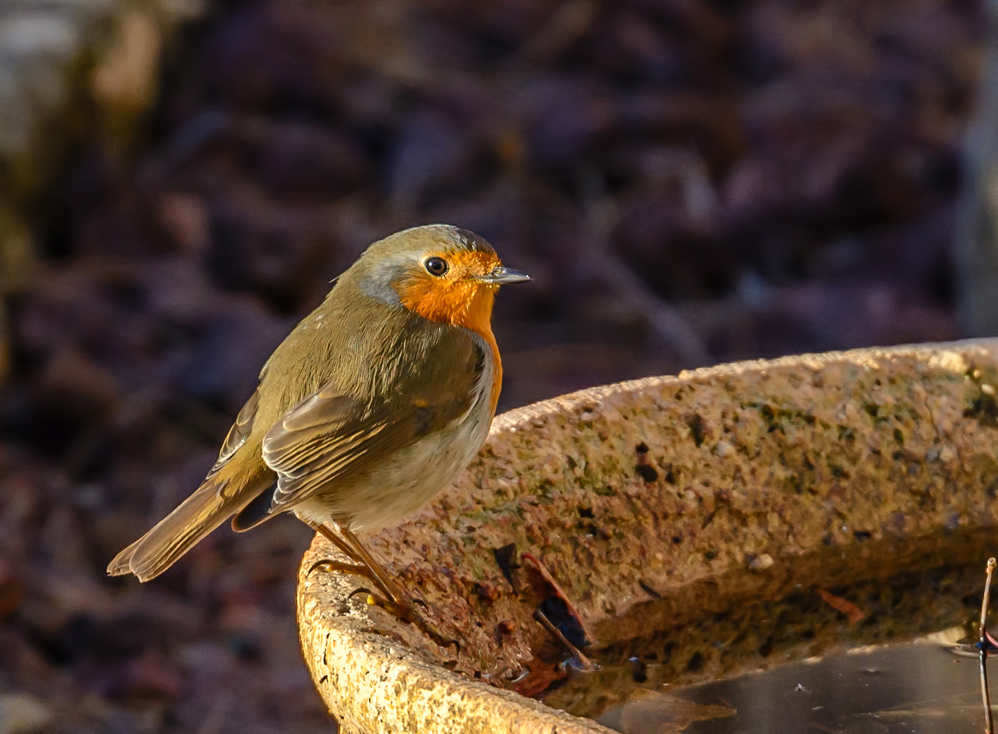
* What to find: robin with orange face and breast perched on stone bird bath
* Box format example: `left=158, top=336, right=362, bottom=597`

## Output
left=107, top=225, right=530, bottom=620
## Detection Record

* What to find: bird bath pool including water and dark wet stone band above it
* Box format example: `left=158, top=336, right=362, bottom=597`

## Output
left=544, top=531, right=998, bottom=734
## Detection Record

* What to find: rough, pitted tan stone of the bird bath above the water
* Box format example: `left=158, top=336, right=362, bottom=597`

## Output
left=298, top=340, right=998, bottom=732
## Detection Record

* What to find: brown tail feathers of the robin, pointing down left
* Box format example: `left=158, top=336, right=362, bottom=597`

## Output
left=107, top=476, right=271, bottom=581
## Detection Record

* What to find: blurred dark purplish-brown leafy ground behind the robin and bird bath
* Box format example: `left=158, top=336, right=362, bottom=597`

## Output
left=0, top=0, right=998, bottom=734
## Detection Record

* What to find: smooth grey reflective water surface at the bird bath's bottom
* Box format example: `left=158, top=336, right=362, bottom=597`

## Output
left=598, top=640, right=984, bottom=734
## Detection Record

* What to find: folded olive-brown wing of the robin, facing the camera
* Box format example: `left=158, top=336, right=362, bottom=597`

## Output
left=263, top=344, right=480, bottom=512
